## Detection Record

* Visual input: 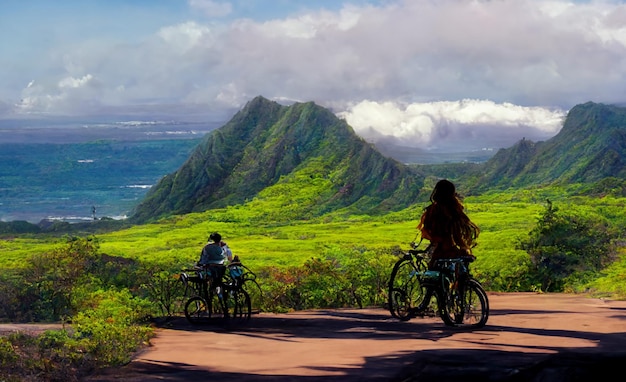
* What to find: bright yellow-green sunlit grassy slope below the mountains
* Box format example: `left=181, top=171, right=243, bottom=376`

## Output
left=0, top=177, right=626, bottom=294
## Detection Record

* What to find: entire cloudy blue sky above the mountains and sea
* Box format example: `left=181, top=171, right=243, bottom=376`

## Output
left=0, top=0, right=626, bottom=148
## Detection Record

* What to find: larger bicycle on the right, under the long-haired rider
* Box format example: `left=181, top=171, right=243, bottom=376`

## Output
left=388, top=242, right=489, bottom=328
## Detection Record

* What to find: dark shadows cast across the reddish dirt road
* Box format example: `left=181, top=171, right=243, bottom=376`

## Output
left=87, top=308, right=626, bottom=382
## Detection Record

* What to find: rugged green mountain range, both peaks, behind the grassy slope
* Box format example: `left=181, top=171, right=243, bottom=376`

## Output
left=130, top=97, right=626, bottom=223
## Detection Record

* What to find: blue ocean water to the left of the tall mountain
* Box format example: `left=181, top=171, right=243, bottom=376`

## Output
left=0, top=120, right=219, bottom=223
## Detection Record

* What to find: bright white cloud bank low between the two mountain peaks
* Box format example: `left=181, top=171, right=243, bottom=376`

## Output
left=338, top=99, right=565, bottom=148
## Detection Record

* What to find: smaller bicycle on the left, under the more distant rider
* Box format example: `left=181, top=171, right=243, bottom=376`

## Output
left=180, top=265, right=252, bottom=324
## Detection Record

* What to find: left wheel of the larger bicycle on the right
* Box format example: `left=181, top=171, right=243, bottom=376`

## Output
left=388, top=258, right=426, bottom=321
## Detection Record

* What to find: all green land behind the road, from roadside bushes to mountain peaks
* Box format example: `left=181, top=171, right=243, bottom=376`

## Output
left=0, top=97, right=626, bottom=379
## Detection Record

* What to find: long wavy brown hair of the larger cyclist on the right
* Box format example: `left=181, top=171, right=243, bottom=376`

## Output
left=420, top=179, right=480, bottom=249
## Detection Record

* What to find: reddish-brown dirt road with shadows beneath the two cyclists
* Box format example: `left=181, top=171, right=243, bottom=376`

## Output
left=84, top=293, right=626, bottom=382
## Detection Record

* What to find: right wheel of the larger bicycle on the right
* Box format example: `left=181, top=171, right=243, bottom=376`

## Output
left=441, top=279, right=489, bottom=328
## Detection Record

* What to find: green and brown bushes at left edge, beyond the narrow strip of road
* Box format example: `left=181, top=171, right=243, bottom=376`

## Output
left=0, top=237, right=151, bottom=321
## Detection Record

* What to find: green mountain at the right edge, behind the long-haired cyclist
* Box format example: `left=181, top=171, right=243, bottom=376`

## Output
left=464, top=102, right=626, bottom=190
